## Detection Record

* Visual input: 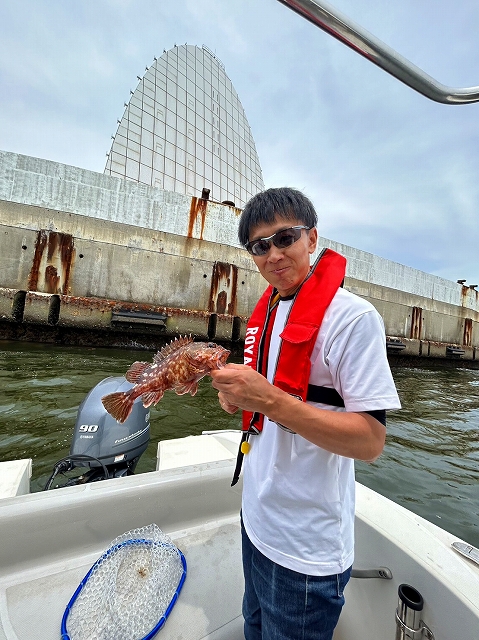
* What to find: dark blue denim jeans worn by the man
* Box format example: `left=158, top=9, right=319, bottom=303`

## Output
left=241, top=526, right=351, bottom=640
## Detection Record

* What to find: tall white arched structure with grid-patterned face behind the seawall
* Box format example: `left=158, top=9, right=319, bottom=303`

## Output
left=105, top=45, right=264, bottom=207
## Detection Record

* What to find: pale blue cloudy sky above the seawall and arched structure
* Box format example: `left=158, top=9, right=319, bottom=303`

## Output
left=0, top=0, right=479, bottom=284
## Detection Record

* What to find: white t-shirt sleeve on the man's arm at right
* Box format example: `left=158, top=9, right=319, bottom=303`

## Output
left=325, top=309, right=401, bottom=411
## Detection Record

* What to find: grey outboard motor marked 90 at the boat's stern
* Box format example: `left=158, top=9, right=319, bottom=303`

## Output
left=45, top=376, right=150, bottom=490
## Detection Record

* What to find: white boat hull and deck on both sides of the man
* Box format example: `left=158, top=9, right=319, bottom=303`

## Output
left=0, top=434, right=479, bottom=640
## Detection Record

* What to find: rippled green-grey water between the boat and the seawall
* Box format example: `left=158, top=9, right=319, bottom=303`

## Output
left=0, top=342, right=479, bottom=547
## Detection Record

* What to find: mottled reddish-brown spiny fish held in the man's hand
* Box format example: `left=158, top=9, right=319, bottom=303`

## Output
left=101, top=336, right=231, bottom=423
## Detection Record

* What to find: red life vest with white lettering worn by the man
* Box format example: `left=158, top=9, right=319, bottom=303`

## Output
left=233, top=249, right=346, bottom=484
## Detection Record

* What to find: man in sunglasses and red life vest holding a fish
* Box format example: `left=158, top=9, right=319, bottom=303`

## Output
left=211, top=188, right=400, bottom=640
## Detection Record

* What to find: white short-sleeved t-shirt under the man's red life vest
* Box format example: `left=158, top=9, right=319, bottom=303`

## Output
left=242, top=288, right=400, bottom=575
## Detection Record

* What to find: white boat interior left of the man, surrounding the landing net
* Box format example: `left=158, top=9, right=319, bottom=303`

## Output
left=0, top=463, right=243, bottom=640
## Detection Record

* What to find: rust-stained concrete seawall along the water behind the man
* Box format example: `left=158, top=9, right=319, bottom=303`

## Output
left=0, top=152, right=479, bottom=364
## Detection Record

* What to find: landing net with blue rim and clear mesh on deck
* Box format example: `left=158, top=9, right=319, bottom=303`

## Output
left=62, top=524, right=186, bottom=640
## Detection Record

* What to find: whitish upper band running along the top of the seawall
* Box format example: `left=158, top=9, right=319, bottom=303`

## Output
left=0, top=151, right=479, bottom=310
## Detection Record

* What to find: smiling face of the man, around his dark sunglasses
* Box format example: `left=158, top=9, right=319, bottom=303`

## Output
left=249, top=217, right=318, bottom=297
